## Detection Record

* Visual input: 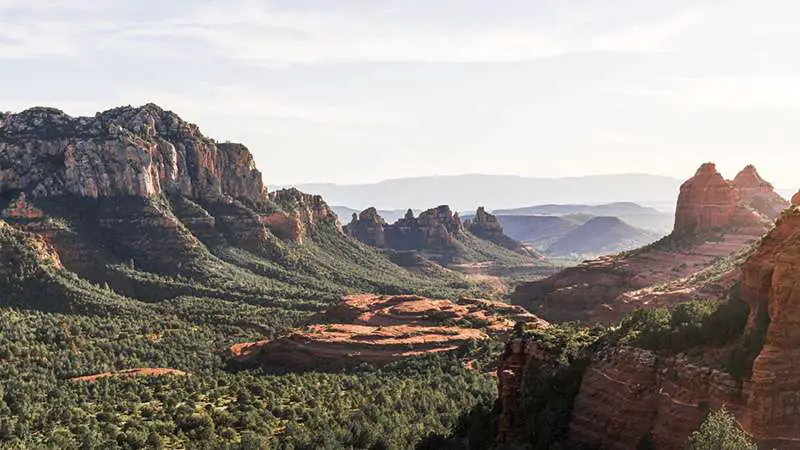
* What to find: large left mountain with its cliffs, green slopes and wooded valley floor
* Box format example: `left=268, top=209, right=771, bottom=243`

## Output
left=0, top=104, right=516, bottom=448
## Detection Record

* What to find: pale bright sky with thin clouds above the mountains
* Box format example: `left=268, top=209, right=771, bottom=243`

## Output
left=0, top=0, right=800, bottom=189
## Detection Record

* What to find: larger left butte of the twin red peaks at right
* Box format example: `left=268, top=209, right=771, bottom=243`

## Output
left=672, top=163, right=760, bottom=235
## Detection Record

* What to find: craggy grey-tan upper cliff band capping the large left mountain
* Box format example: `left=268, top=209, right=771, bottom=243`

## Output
left=0, top=104, right=266, bottom=205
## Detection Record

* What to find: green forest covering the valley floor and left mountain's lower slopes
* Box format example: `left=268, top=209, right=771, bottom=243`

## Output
left=0, top=194, right=510, bottom=449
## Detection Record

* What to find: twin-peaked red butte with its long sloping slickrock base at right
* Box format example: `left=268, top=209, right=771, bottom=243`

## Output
left=512, top=163, right=788, bottom=323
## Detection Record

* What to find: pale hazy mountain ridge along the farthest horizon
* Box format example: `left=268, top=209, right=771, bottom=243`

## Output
left=278, top=174, right=682, bottom=211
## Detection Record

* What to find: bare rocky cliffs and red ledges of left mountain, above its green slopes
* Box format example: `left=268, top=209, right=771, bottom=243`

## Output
left=0, top=104, right=341, bottom=279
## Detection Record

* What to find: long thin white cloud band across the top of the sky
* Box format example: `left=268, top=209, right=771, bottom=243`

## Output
left=0, top=0, right=698, bottom=65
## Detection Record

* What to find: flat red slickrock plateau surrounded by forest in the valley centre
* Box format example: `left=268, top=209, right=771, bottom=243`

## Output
left=229, top=294, right=547, bottom=370
